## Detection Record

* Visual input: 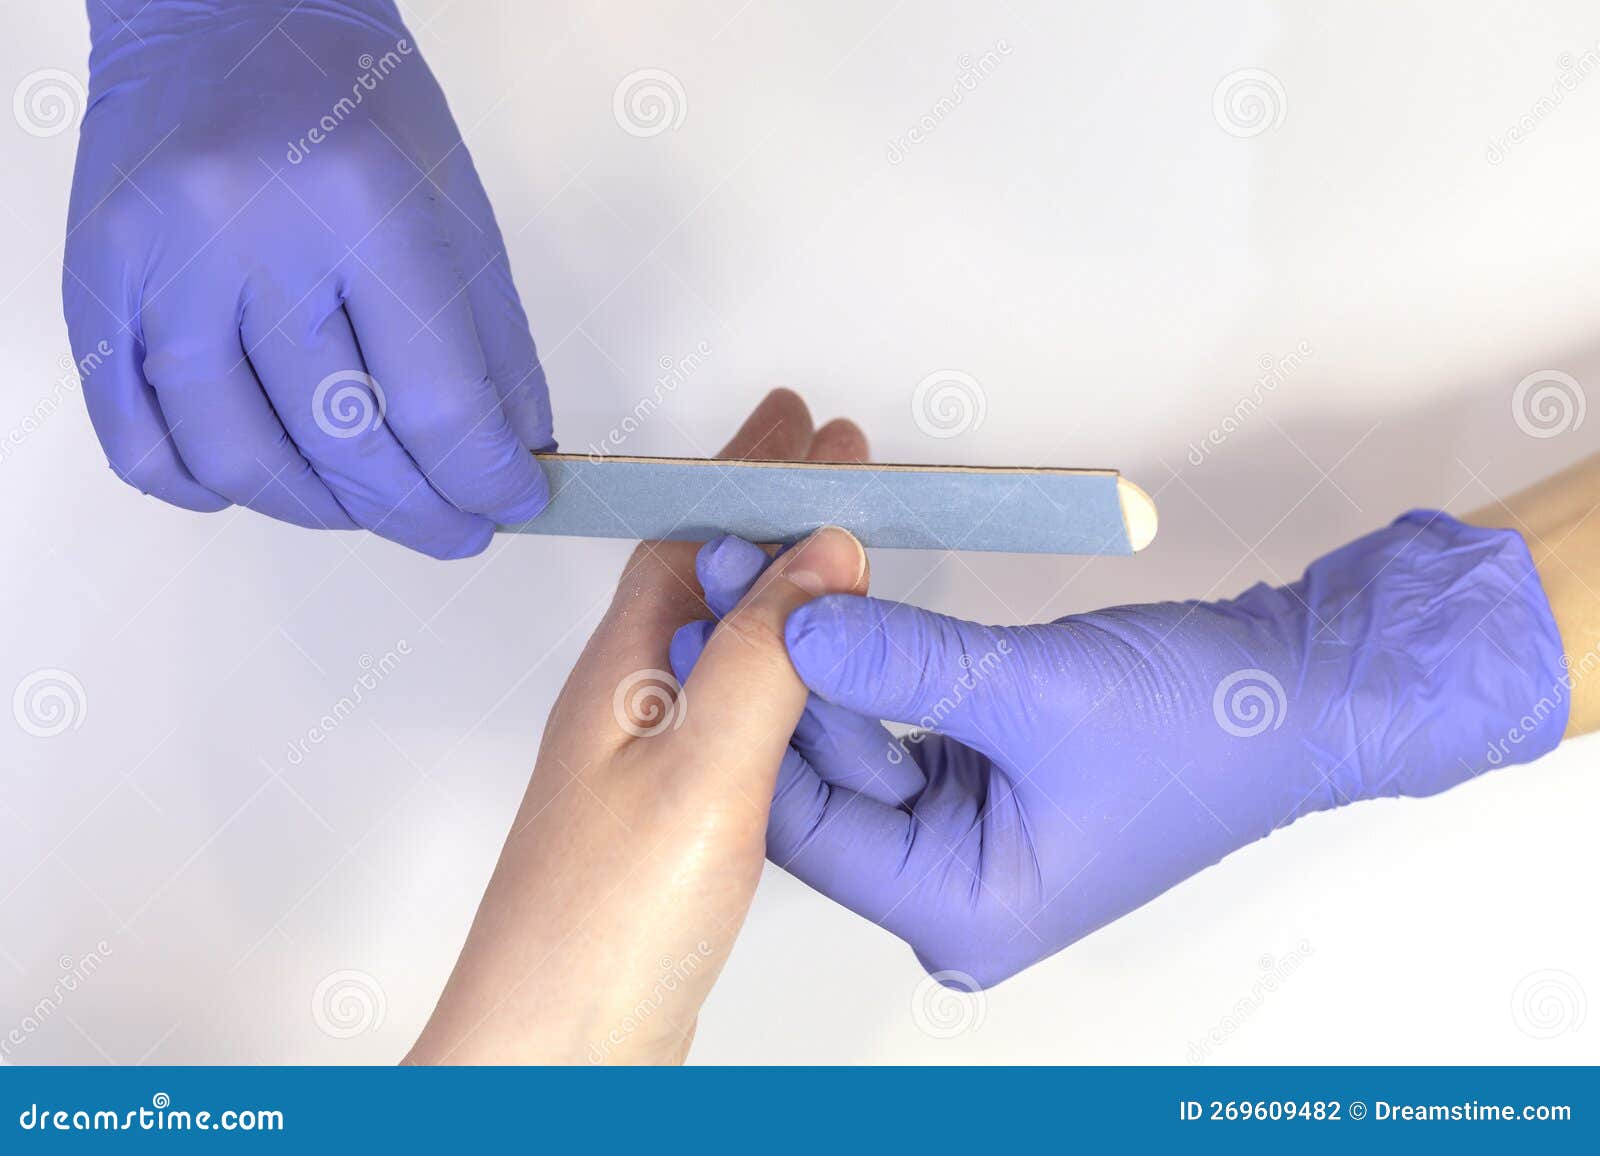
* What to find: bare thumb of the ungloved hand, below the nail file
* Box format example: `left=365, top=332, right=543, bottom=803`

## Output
left=672, top=527, right=867, bottom=797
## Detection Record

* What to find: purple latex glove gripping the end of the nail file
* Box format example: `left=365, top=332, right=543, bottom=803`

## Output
left=62, top=0, right=552, bottom=557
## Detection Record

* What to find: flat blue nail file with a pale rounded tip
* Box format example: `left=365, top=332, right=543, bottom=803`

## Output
left=501, top=453, right=1157, bottom=554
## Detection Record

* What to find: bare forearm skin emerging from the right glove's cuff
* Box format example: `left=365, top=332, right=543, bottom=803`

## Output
left=1464, top=455, right=1600, bottom=738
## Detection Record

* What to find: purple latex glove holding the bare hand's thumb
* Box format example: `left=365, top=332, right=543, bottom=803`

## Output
left=674, top=512, right=1570, bottom=986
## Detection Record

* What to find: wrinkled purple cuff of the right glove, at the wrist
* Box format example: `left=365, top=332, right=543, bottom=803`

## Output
left=1290, top=511, right=1573, bottom=797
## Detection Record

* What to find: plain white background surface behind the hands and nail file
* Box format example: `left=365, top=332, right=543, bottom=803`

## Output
left=0, top=0, right=1600, bottom=1063
